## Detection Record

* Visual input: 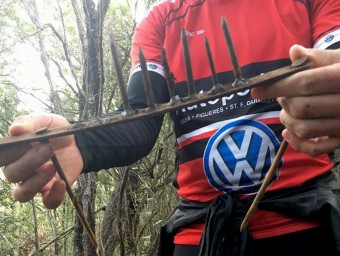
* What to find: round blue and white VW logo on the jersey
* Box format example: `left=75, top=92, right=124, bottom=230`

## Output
left=203, top=120, right=282, bottom=194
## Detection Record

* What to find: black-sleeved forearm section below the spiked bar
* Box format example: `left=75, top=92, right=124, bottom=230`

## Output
left=76, top=116, right=163, bottom=172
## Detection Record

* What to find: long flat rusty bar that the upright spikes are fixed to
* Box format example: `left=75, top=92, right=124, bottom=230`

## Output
left=0, top=59, right=312, bottom=147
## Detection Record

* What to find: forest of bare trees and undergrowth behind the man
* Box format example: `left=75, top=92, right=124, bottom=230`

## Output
left=0, top=0, right=339, bottom=256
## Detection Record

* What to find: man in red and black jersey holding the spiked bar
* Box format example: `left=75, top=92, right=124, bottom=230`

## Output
left=0, top=0, right=340, bottom=256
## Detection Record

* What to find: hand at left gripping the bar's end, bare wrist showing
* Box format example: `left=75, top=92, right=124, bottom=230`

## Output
left=0, top=114, right=83, bottom=209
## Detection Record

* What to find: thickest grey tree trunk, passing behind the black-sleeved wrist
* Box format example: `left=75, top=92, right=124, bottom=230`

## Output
left=74, top=0, right=110, bottom=256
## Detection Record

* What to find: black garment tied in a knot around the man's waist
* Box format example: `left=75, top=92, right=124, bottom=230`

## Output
left=157, top=172, right=340, bottom=256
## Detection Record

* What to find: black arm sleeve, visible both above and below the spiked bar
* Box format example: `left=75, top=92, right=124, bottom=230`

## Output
left=76, top=72, right=169, bottom=172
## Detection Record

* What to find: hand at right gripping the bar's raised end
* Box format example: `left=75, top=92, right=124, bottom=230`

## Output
left=252, top=45, right=340, bottom=156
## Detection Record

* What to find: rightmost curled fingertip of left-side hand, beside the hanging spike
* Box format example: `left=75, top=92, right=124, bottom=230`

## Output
left=41, top=179, right=66, bottom=209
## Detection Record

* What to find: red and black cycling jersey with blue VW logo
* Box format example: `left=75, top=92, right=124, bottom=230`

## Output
left=131, top=0, right=340, bottom=244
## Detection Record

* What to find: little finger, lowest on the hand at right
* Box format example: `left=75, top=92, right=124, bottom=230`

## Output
left=282, top=130, right=340, bottom=156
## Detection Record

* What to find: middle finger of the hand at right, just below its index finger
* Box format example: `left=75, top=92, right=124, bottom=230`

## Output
left=278, top=94, right=340, bottom=119
